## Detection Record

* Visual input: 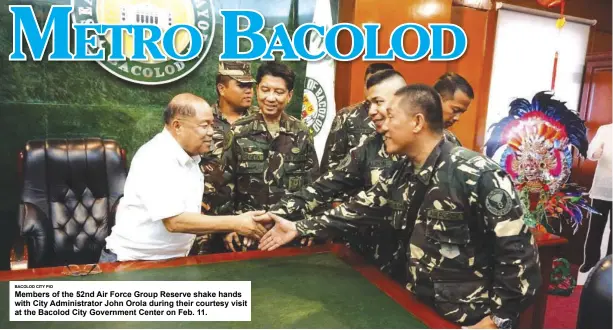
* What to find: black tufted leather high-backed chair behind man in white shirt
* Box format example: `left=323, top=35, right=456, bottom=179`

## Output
left=19, top=138, right=127, bottom=268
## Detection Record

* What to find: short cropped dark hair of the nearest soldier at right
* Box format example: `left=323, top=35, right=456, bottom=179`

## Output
left=395, top=84, right=443, bottom=133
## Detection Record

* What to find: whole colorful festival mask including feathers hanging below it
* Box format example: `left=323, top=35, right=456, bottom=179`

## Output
left=485, top=92, right=593, bottom=231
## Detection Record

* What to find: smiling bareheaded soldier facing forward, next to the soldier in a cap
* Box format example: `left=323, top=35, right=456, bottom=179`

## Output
left=222, top=62, right=319, bottom=251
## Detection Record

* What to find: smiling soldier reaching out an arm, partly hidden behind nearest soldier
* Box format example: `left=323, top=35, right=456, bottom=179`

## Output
left=270, top=70, right=407, bottom=284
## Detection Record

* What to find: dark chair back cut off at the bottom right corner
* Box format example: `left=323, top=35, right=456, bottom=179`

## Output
left=577, top=255, right=613, bottom=329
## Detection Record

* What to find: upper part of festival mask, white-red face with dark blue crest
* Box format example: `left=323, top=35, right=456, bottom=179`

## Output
left=485, top=92, right=588, bottom=192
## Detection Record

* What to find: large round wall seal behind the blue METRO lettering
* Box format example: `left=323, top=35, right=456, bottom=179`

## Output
left=72, top=0, right=215, bottom=85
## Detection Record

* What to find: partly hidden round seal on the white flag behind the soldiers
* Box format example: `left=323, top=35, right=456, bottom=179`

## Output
left=301, top=77, right=328, bottom=136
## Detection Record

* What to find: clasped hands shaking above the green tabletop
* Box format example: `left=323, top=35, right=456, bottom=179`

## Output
left=224, top=211, right=312, bottom=251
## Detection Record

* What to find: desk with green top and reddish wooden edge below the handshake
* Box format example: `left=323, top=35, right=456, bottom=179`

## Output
left=0, top=244, right=460, bottom=329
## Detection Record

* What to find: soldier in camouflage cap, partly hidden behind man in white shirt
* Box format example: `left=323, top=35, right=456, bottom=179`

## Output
left=190, top=62, right=258, bottom=254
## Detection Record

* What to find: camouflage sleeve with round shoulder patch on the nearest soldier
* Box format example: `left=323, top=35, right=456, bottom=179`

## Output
left=478, top=171, right=542, bottom=320
